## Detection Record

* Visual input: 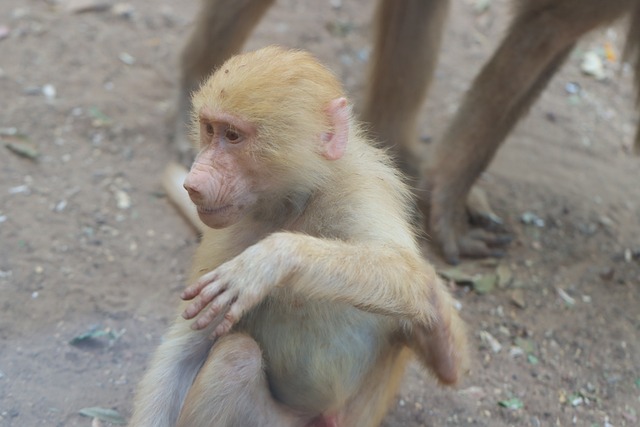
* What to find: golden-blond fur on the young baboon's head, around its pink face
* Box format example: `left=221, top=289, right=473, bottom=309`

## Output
left=193, top=46, right=345, bottom=189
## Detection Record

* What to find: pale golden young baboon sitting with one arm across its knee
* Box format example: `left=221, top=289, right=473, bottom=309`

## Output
left=130, top=47, right=467, bottom=427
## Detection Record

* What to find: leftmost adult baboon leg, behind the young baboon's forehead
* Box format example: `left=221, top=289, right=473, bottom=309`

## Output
left=173, top=0, right=274, bottom=164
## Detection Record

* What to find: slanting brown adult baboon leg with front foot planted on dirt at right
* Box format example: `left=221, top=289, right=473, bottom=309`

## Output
left=420, top=0, right=629, bottom=263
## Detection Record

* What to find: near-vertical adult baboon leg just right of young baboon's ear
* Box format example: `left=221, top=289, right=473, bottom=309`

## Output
left=361, top=0, right=449, bottom=177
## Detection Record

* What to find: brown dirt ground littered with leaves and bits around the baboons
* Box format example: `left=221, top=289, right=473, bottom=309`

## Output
left=0, top=0, right=640, bottom=427
